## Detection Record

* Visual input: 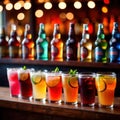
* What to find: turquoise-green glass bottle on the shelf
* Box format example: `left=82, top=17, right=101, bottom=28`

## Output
left=36, top=23, right=48, bottom=60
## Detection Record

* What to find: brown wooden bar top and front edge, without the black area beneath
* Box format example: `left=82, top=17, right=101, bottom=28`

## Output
left=0, top=87, right=120, bottom=120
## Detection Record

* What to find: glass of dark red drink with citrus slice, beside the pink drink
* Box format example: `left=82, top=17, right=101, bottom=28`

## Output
left=18, top=68, right=33, bottom=99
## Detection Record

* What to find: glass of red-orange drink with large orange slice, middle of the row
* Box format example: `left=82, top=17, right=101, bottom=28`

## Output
left=46, top=73, right=62, bottom=103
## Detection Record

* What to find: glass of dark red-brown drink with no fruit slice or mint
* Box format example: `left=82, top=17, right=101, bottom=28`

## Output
left=79, top=72, right=96, bottom=106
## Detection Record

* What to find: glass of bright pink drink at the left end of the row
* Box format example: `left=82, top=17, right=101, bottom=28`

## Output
left=7, top=68, right=20, bottom=97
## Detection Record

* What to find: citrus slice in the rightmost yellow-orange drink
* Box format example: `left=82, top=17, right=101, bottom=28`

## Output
left=97, top=77, right=107, bottom=92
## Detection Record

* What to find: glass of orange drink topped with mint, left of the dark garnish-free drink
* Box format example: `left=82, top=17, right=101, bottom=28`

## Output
left=62, top=74, right=78, bottom=104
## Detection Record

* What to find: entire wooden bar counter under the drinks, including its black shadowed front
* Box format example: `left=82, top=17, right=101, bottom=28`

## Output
left=0, top=87, right=120, bottom=120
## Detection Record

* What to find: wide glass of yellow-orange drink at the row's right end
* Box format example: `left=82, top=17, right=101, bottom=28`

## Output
left=96, top=73, right=116, bottom=107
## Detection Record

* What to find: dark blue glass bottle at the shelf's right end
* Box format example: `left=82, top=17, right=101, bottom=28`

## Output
left=109, top=22, right=120, bottom=63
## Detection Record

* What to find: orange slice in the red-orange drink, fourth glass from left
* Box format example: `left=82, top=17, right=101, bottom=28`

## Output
left=46, top=76, right=60, bottom=87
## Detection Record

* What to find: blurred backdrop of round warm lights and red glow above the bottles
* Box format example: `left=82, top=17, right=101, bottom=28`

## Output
left=0, top=0, right=120, bottom=40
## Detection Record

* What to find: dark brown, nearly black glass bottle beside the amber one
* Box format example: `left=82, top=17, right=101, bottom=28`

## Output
left=66, top=23, right=78, bottom=61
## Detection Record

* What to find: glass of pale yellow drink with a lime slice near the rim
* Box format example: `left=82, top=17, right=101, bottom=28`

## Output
left=30, top=71, right=46, bottom=102
